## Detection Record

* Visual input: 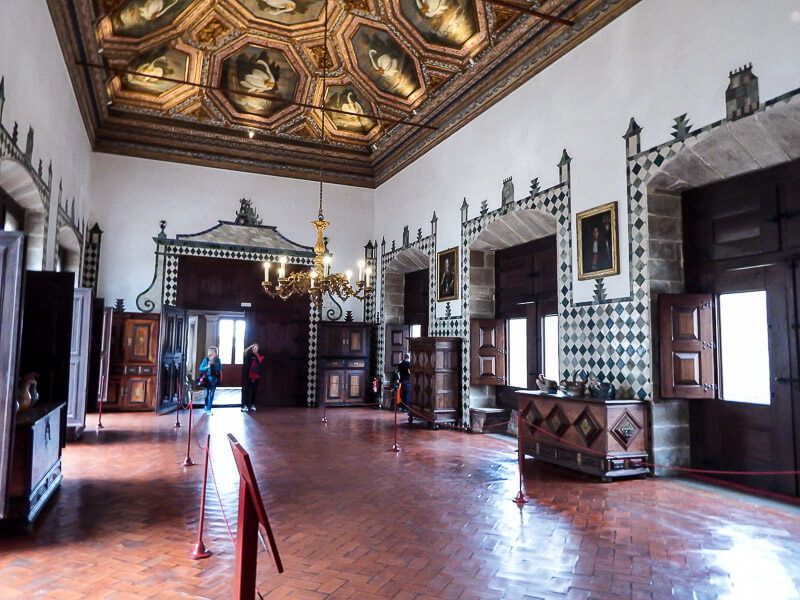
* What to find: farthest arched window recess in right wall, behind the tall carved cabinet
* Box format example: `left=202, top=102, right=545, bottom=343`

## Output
left=383, top=248, right=431, bottom=380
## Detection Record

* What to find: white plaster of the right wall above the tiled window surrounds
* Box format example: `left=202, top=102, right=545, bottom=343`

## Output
left=375, top=0, right=800, bottom=314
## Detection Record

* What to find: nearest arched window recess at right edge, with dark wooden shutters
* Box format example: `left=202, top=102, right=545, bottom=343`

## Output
left=647, top=98, right=800, bottom=494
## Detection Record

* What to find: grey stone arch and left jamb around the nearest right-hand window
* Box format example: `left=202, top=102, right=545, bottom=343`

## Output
left=626, top=94, right=800, bottom=473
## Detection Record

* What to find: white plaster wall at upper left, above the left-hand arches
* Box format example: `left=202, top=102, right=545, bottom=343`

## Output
left=0, top=0, right=91, bottom=268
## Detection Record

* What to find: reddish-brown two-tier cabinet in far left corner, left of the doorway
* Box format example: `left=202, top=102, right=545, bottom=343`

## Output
left=108, top=313, right=160, bottom=411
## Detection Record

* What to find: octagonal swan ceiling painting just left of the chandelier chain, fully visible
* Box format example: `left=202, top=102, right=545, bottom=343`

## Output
left=222, top=46, right=298, bottom=117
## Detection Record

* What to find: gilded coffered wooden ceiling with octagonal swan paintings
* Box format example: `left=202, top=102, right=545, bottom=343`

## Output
left=48, top=0, right=638, bottom=187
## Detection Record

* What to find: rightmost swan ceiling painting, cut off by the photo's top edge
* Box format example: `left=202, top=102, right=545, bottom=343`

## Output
left=400, top=0, right=480, bottom=49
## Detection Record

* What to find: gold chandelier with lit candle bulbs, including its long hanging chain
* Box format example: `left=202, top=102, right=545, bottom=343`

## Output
left=261, top=2, right=374, bottom=307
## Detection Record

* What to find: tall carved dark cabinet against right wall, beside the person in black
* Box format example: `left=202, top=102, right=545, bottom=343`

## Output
left=408, top=337, right=461, bottom=429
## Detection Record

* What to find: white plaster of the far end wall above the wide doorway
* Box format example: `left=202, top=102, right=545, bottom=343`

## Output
left=92, top=154, right=374, bottom=320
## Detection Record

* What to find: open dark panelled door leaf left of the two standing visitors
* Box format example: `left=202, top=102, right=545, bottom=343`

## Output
left=156, top=306, right=188, bottom=413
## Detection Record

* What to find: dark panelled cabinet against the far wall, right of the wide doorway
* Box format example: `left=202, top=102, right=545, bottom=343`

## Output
left=318, top=322, right=371, bottom=406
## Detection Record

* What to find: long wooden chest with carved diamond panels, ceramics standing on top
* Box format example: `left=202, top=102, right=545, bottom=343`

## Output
left=517, top=390, right=650, bottom=481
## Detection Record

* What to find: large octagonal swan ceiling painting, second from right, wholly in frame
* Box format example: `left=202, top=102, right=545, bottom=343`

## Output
left=353, top=25, right=420, bottom=98
